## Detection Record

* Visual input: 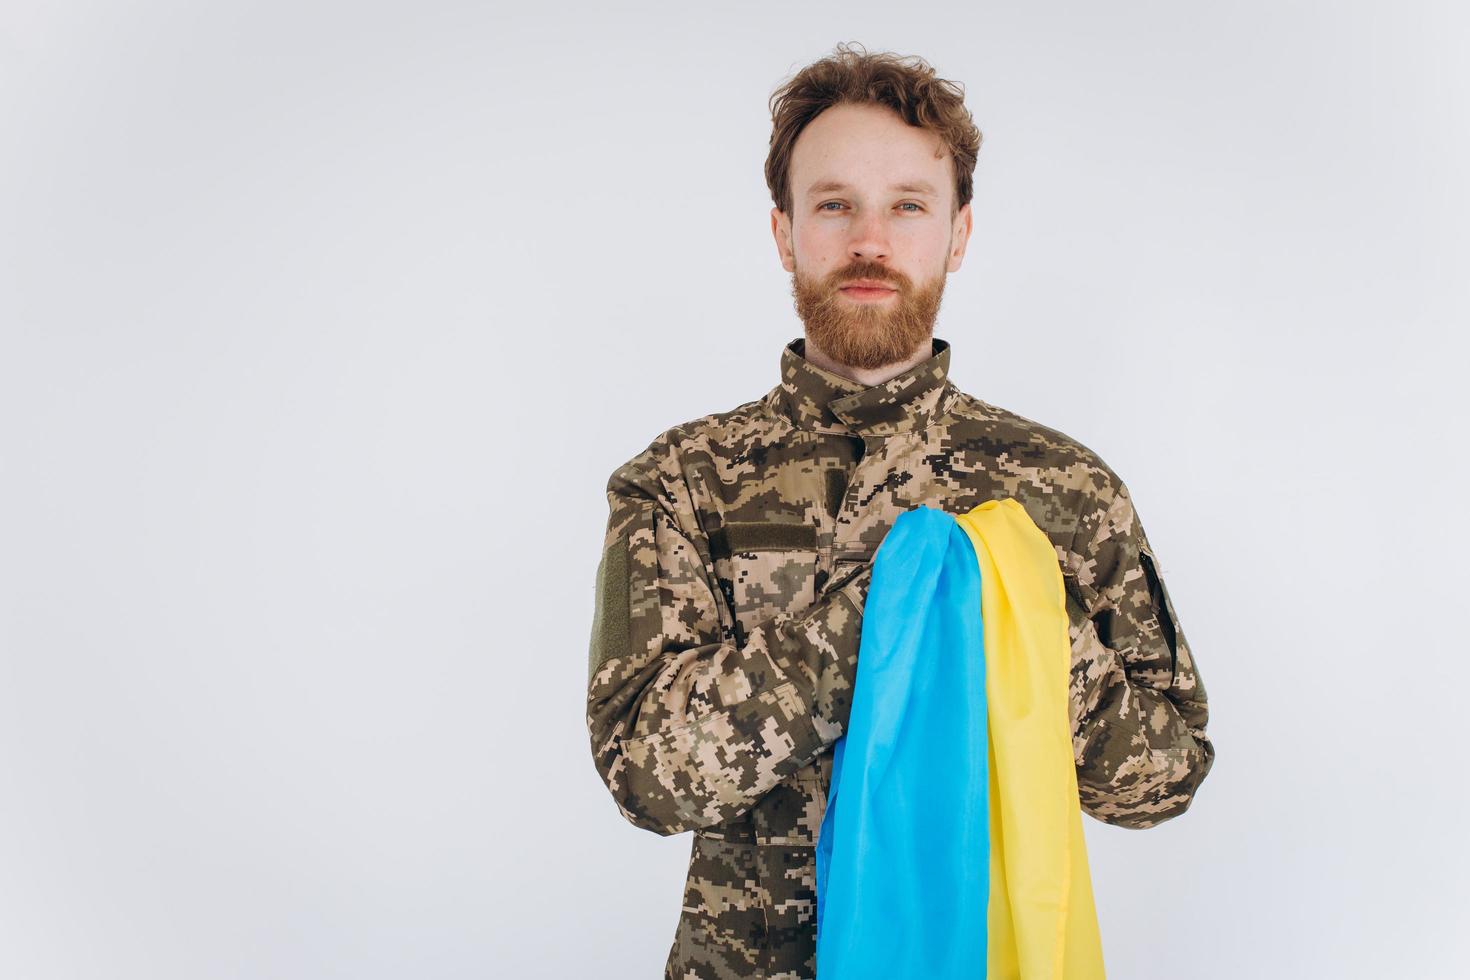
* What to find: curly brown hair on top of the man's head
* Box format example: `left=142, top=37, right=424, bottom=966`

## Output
left=766, top=43, right=980, bottom=217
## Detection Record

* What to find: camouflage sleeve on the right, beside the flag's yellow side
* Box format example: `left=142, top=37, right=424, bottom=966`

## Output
left=1072, top=480, right=1214, bottom=829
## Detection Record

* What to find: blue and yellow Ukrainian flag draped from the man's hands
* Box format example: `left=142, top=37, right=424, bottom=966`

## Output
left=816, top=498, right=1104, bottom=980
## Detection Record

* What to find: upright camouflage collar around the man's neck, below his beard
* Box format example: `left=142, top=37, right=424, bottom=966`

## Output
left=764, top=336, right=960, bottom=436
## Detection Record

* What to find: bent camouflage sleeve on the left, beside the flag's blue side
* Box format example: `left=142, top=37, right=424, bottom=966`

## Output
left=587, top=464, right=872, bottom=835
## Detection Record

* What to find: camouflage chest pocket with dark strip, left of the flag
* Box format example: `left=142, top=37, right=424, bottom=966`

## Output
left=710, top=522, right=817, bottom=644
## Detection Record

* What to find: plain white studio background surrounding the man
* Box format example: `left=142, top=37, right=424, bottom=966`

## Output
left=0, top=0, right=1470, bottom=980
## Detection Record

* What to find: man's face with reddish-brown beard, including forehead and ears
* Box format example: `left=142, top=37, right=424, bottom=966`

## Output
left=770, top=104, right=970, bottom=369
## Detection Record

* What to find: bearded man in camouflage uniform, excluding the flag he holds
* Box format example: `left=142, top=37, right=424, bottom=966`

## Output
left=587, top=46, right=1214, bottom=980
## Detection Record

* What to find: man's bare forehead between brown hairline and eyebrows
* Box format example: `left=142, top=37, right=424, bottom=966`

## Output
left=791, top=104, right=951, bottom=197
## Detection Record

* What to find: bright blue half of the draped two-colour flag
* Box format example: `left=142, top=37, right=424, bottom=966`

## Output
left=816, top=505, right=991, bottom=980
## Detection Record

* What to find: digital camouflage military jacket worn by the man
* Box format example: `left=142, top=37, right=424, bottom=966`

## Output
left=587, top=338, right=1214, bottom=980
